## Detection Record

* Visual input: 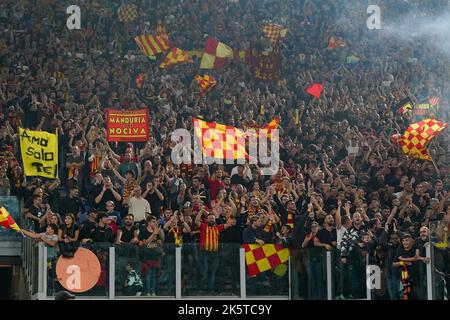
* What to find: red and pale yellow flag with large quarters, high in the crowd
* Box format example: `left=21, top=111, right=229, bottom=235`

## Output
left=200, top=37, right=234, bottom=69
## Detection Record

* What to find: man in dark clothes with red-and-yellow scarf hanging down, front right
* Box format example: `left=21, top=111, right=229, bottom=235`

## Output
left=393, top=233, right=419, bottom=300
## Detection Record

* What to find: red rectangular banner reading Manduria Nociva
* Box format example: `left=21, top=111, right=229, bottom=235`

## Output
left=106, top=109, right=149, bottom=141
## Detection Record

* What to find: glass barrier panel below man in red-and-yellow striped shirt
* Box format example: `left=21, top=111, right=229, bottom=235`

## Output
left=181, top=243, right=240, bottom=297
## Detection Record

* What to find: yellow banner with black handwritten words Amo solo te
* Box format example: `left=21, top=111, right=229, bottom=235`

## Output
left=19, top=128, right=58, bottom=179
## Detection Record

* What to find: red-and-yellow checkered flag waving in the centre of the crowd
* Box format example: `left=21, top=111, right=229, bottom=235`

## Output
left=192, top=118, right=248, bottom=159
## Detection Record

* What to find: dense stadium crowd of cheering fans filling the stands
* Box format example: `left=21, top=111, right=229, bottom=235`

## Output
left=0, top=0, right=450, bottom=299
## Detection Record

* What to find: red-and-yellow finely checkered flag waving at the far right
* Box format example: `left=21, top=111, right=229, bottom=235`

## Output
left=393, top=119, right=447, bottom=161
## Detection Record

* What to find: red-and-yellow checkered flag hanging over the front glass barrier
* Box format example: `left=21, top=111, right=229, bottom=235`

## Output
left=242, top=244, right=289, bottom=276
